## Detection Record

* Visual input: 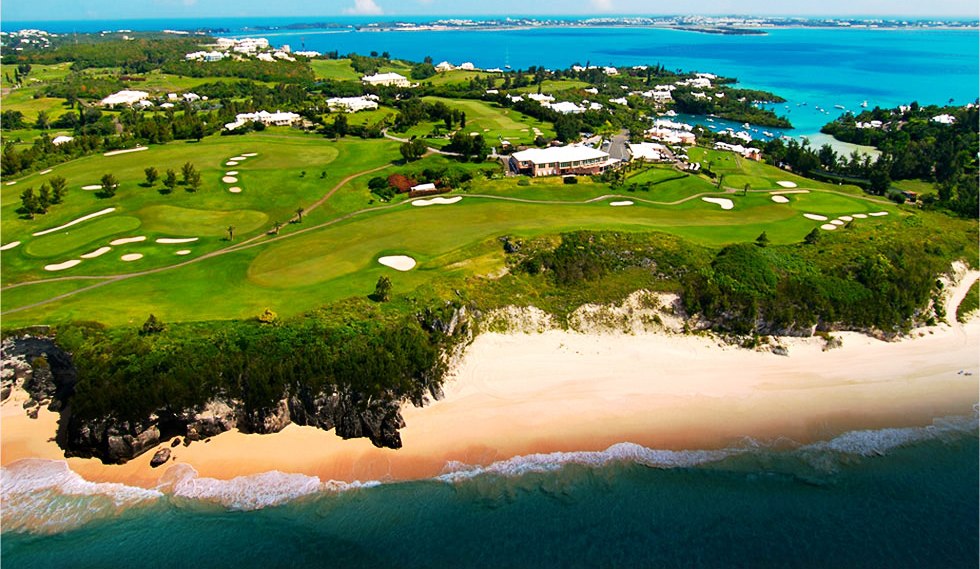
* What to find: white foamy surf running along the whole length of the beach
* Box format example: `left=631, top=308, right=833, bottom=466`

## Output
left=0, top=407, right=978, bottom=533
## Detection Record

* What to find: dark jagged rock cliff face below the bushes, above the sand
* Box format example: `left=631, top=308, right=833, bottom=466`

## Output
left=0, top=308, right=472, bottom=464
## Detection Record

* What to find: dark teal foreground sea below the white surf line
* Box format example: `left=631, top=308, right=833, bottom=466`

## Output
left=0, top=424, right=980, bottom=569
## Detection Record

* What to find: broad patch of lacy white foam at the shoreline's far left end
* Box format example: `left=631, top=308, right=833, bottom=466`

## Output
left=0, top=458, right=163, bottom=533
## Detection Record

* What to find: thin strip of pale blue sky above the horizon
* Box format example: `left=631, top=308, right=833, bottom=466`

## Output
left=0, top=0, right=980, bottom=21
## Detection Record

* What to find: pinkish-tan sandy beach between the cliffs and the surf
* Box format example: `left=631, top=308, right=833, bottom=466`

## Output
left=0, top=275, right=980, bottom=488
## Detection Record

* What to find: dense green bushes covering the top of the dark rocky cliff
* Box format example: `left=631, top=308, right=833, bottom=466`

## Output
left=56, top=300, right=449, bottom=421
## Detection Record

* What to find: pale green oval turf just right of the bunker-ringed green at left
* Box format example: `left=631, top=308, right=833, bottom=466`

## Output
left=137, top=205, right=269, bottom=237
